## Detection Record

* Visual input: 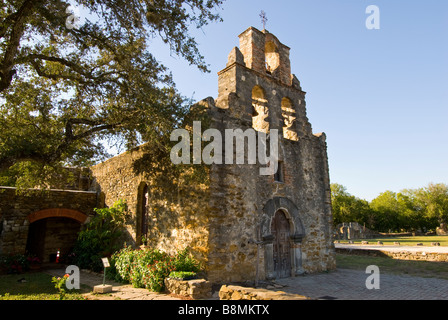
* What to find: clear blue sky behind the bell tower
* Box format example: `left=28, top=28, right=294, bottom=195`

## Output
left=149, top=0, right=448, bottom=200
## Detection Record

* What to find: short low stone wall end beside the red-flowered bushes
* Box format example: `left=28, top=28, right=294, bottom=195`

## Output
left=165, top=278, right=212, bottom=300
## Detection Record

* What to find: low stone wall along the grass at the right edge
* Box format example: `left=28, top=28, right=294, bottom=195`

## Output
left=336, top=248, right=448, bottom=262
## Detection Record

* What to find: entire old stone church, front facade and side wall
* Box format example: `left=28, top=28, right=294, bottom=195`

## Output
left=92, top=27, right=335, bottom=282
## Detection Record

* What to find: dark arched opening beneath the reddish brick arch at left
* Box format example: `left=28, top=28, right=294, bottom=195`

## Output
left=26, top=217, right=82, bottom=263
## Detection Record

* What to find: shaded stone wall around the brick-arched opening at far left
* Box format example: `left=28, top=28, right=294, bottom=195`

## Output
left=0, top=187, right=98, bottom=260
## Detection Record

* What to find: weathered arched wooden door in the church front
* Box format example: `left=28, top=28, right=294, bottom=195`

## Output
left=271, top=210, right=291, bottom=278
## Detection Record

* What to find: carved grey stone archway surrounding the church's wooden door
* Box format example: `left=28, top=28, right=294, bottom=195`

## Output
left=259, top=197, right=305, bottom=279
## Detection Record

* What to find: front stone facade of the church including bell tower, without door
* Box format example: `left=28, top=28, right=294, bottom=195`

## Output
left=209, top=28, right=335, bottom=281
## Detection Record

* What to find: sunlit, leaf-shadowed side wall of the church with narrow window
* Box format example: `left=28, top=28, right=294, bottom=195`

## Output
left=91, top=140, right=213, bottom=263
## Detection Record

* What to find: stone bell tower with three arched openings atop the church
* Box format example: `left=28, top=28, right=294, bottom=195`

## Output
left=217, top=27, right=312, bottom=141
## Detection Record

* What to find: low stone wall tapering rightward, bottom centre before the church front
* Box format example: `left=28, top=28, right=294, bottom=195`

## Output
left=219, top=285, right=310, bottom=300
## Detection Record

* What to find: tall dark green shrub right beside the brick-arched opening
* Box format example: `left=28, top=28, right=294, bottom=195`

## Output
left=71, top=200, right=128, bottom=271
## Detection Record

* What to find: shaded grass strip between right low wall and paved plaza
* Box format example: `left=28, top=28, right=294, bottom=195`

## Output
left=336, top=254, right=448, bottom=280
